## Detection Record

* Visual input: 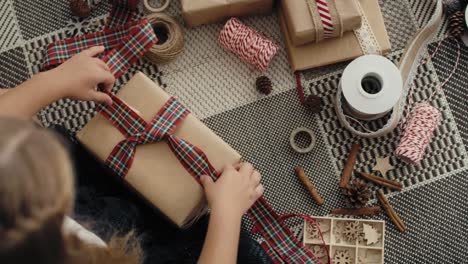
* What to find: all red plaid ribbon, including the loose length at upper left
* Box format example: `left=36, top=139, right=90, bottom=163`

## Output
left=44, top=0, right=319, bottom=263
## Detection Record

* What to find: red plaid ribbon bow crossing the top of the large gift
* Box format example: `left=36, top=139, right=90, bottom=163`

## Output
left=101, top=95, right=217, bottom=180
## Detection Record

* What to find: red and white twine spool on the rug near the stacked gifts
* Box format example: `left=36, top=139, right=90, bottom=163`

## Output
left=218, top=18, right=279, bottom=71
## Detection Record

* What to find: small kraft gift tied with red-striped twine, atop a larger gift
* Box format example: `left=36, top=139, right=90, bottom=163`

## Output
left=281, top=0, right=361, bottom=46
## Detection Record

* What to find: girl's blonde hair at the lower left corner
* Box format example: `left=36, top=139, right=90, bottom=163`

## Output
left=0, top=118, right=142, bottom=264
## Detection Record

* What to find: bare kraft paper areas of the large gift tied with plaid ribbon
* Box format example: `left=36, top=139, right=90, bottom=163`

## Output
left=77, top=73, right=241, bottom=227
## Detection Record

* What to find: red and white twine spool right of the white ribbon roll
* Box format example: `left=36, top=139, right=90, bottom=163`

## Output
left=395, top=103, right=442, bottom=164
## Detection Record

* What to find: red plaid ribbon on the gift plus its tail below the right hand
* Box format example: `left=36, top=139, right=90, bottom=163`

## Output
left=101, top=96, right=324, bottom=263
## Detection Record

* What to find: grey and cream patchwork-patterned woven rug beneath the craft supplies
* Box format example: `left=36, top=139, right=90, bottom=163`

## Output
left=0, top=0, right=468, bottom=263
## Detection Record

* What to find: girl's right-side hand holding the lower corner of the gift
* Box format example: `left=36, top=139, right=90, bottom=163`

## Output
left=201, top=163, right=263, bottom=219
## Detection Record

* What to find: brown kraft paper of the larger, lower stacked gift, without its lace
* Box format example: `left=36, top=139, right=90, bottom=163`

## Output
left=280, top=0, right=391, bottom=71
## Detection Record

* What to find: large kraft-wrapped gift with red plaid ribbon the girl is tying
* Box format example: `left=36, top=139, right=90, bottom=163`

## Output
left=77, top=73, right=241, bottom=227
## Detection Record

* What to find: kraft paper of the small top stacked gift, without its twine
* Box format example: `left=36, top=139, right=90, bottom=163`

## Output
left=281, top=0, right=361, bottom=46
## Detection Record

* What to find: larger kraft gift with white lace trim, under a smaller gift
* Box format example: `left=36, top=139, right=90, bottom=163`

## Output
left=280, top=0, right=391, bottom=71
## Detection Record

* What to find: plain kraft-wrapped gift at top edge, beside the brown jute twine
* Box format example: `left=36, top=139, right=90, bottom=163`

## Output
left=181, top=0, right=274, bottom=27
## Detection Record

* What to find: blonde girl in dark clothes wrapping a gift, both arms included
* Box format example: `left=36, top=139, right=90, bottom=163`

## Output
left=0, top=47, right=269, bottom=264
